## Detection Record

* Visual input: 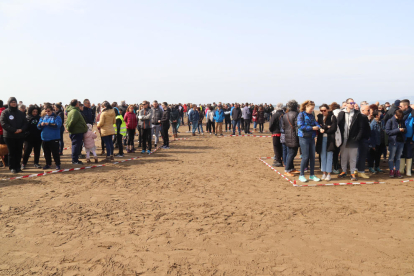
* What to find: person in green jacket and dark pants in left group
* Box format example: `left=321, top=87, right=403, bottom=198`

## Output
left=66, top=99, right=88, bottom=165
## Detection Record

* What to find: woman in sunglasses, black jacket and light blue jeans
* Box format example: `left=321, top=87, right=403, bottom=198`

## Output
left=316, top=104, right=337, bottom=181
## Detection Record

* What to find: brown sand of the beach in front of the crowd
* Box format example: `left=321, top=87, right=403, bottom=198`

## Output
left=0, top=123, right=414, bottom=276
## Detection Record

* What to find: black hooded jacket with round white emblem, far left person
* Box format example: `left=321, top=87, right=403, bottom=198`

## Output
left=0, top=97, right=28, bottom=139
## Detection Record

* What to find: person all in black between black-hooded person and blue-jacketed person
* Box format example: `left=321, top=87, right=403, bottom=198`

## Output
left=21, top=105, right=42, bottom=170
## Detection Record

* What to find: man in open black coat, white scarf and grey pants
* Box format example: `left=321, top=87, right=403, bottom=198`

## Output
left=338, top=98, right=363, bottom=181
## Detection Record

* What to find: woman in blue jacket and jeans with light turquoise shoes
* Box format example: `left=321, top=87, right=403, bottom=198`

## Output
left=297, top=100, right=325, bottom=182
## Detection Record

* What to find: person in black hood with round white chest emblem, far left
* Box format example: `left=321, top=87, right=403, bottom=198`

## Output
left=0, top=97, right=27, bottom=173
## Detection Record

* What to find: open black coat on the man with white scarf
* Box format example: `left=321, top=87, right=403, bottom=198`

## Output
left=338, top=110, right=364, bottom=148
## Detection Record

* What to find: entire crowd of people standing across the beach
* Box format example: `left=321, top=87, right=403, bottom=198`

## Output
left=0, top=97, right=414, bottom=182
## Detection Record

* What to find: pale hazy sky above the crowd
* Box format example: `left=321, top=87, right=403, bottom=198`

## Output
left=0, top=0, right=414, bottom=104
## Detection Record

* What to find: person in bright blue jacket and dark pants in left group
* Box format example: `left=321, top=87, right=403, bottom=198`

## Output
left=37, top=105, right=62, bottom=170
